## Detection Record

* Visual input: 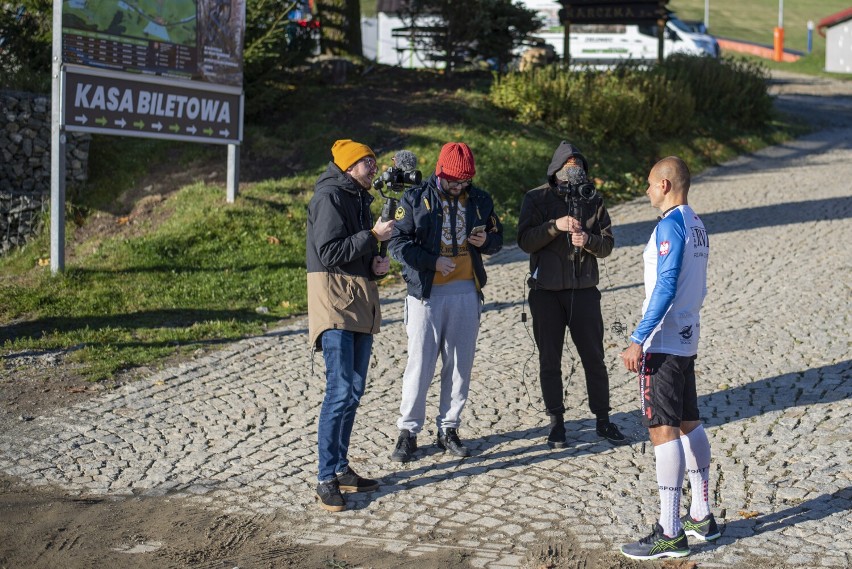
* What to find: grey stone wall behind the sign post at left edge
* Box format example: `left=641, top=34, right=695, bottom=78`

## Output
left=0, top=91, right=91, bottom=255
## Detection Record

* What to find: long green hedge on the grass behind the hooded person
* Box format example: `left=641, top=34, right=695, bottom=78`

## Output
left=490, top=56, right=772, bottom=146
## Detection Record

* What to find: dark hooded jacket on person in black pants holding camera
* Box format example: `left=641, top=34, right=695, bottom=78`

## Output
left=518, top=141, right=615, bottom=290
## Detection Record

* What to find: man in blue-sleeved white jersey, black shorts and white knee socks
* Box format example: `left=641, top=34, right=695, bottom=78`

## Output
left=621, top=156, right=721, bottom=559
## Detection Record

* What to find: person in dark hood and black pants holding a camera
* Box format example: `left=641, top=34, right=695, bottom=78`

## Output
left=518, top=141, right=625, bottom=448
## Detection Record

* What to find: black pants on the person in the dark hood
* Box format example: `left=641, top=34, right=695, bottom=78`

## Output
left=529, top=287, right=610, bottom=419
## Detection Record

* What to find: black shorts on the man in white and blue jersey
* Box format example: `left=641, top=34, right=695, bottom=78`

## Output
left=639, top=353, right=700, bottom=427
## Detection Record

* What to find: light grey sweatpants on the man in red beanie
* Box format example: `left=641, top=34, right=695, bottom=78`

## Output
left=396, top=280, right=482, bottom=435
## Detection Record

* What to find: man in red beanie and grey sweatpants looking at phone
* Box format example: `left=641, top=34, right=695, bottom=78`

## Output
left=388, top=142, right=503, bottom=462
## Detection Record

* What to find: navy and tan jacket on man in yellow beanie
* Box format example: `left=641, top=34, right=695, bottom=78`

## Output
left=306, top=162, right=382, bottom=350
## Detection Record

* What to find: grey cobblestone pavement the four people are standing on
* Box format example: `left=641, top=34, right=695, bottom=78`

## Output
left=0, top=81, right=852, bottom=568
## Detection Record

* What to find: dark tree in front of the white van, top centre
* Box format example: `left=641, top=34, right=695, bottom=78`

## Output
left=400, top=0, right=541, bottom=72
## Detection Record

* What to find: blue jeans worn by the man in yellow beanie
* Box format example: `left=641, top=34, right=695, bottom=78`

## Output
left=317, top=330, right=373, bottom=482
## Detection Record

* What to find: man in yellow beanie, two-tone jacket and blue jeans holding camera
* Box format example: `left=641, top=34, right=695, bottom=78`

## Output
left=306, top=139, right=394, bottom=512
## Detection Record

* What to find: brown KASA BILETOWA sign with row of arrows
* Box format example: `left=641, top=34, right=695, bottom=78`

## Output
left=62, top=65, right=243, bottom=144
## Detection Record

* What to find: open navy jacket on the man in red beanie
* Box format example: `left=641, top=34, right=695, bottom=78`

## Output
left=388, top=174, right=503, bottom=299
